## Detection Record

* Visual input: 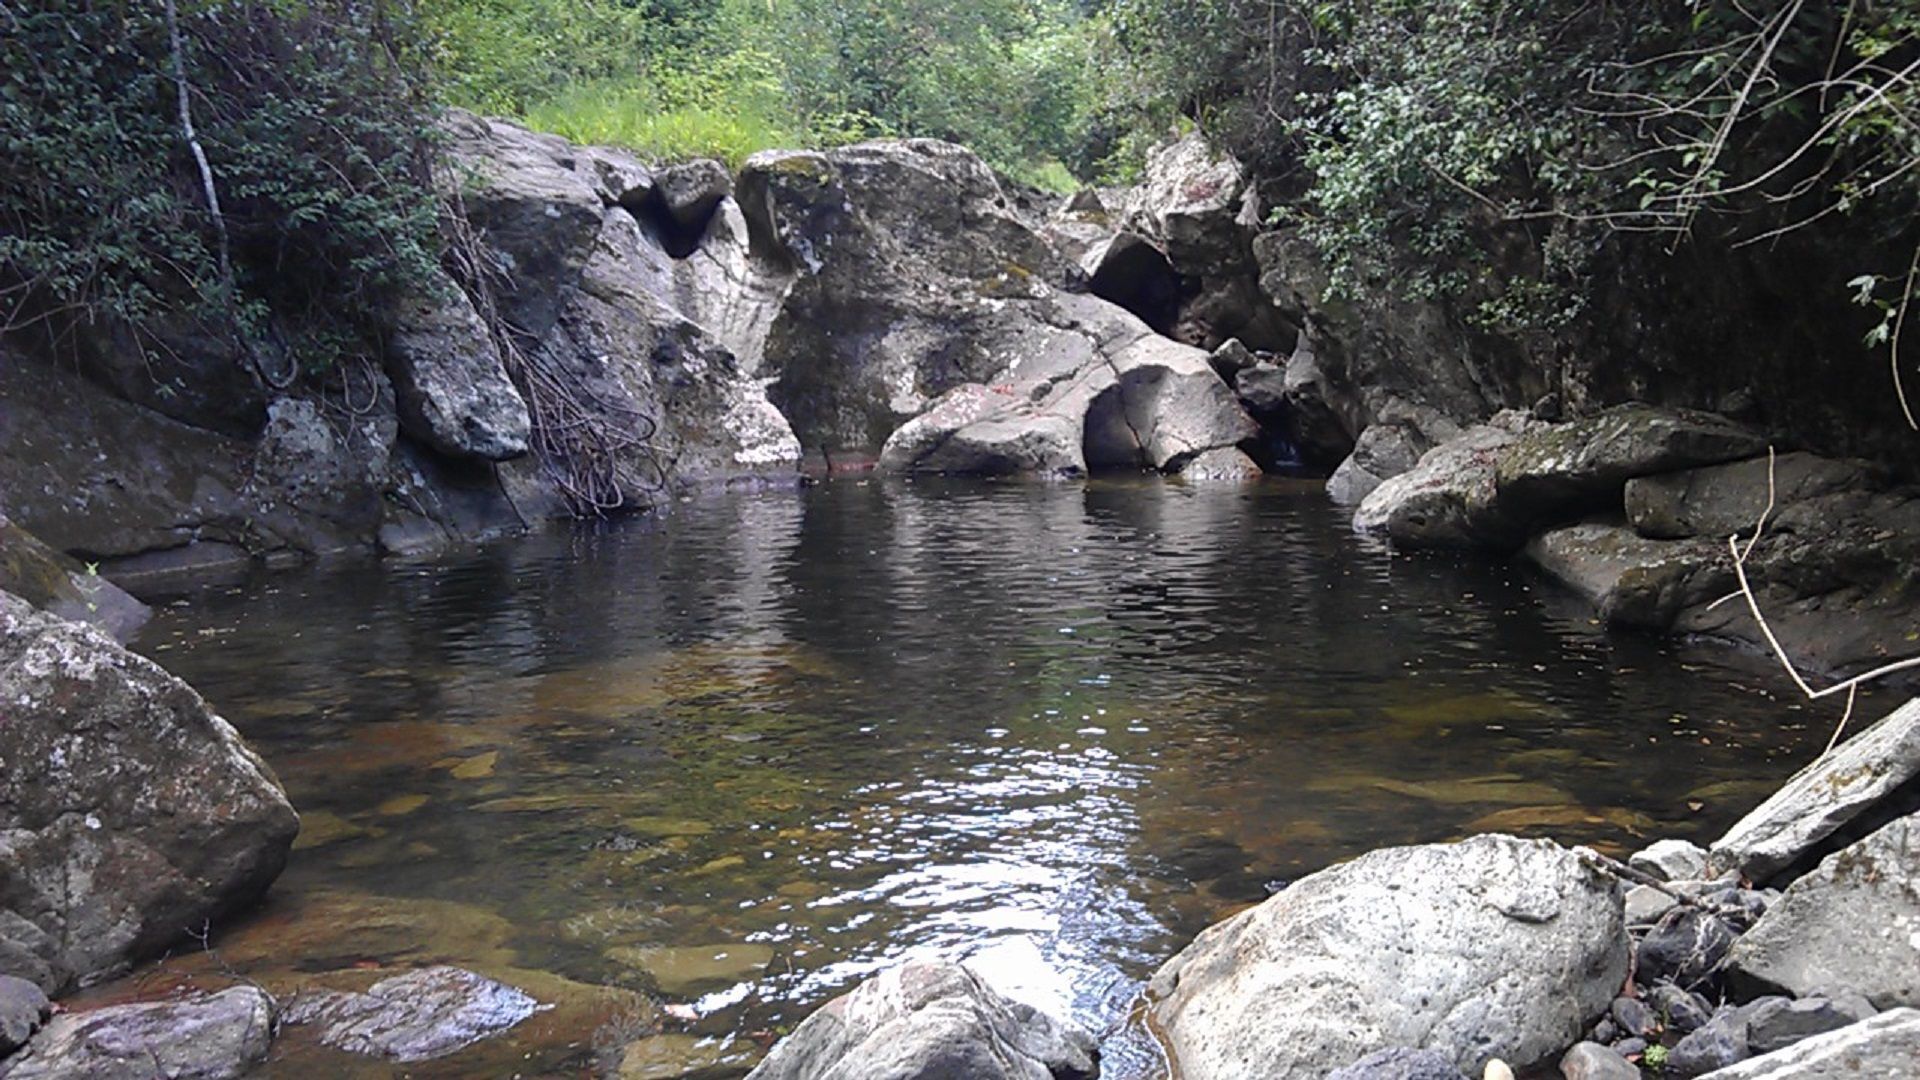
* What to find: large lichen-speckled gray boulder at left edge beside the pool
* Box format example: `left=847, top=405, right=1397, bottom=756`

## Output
left=0, top=594, right=300, bottom=994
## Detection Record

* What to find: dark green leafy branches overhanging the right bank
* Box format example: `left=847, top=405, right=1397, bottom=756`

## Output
left=1112, top=0, right=1920, bottom=329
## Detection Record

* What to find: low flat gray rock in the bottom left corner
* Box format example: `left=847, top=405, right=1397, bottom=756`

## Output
left=0, top=986, right=273, bottom=1080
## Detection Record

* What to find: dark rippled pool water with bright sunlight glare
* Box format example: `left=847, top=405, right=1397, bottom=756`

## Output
left=138, top=479, right=1864, bottom=1080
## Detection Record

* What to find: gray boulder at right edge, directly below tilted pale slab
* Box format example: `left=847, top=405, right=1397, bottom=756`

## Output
left=1728, top=813, right=1920, bottom=1009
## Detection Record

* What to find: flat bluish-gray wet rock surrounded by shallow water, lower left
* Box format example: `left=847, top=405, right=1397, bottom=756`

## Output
left=282, top=967, right=540, bottom=1061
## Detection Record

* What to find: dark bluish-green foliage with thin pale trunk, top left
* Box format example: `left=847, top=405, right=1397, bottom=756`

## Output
left=0, top=0, right=438, bottom=365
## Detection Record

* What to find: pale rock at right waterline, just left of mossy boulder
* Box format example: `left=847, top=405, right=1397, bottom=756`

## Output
left=1354, top=411, right=1538, bottom=552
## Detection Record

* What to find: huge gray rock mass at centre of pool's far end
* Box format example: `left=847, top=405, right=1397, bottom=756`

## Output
left=739, top=140, right=1256, bottom=475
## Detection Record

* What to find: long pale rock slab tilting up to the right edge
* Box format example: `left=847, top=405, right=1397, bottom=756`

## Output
left=1711, top=701, right=1920, bottom=882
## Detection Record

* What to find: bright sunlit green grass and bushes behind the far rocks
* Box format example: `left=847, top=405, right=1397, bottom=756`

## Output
left=428, top=0, right=1102, bottom=188
